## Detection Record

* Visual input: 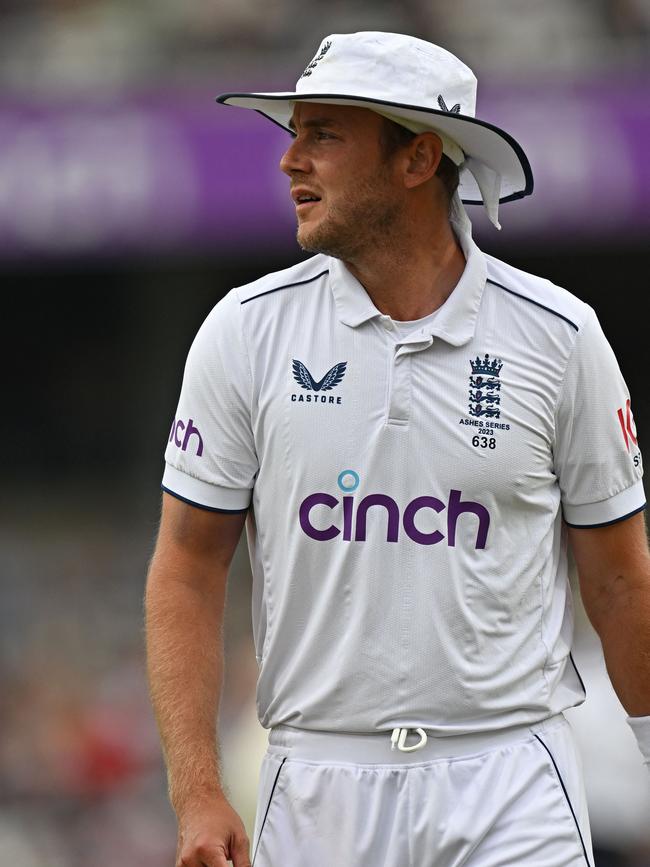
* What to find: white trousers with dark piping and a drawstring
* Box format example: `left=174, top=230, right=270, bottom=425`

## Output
left=252, top=715, right=594, bottom=867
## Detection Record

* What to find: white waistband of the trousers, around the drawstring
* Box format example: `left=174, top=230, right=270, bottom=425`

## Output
left=269, top=714, right=568, bottom=764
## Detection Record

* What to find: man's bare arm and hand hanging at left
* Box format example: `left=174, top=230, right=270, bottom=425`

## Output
left=145, top=494, right=250, bottom=867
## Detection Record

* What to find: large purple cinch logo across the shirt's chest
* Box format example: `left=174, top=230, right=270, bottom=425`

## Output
left=299, top=470, right=490, bottom=548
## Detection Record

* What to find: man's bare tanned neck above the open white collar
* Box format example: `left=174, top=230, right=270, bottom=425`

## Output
left=344, top=218, right=465, bottom=322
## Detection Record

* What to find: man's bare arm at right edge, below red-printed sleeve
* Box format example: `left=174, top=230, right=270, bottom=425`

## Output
left=569, top=513, right=650, bottom=724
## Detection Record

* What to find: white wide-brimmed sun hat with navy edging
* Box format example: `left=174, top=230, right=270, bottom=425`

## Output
left=217, top=32, right=533, bottom=228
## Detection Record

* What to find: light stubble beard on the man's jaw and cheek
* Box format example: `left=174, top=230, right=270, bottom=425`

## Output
left=296, top=171, right=402, bottom=262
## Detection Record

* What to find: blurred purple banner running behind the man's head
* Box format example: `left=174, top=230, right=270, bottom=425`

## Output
left=0, top=81, right=650, bottom=258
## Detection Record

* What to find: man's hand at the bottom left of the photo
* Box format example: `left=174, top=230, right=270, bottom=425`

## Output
left=176, top=795, right=251, bottom=867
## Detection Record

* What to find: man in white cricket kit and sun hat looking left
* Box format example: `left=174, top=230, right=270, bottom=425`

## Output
left=146, top=33, right=650, bottom=867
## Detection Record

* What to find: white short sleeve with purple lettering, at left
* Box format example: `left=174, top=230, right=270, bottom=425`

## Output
left=163, top=292, right=258, bottom=512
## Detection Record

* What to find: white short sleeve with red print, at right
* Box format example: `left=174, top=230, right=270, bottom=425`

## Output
left=554, top=308, right=645, bottom=528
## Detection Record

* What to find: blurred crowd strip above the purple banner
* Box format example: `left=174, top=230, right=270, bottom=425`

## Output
left=0, top=0, right=650, bottom=92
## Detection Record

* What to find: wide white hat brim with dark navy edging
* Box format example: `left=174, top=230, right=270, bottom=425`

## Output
left=217, top=93, right=533, bottom=205
